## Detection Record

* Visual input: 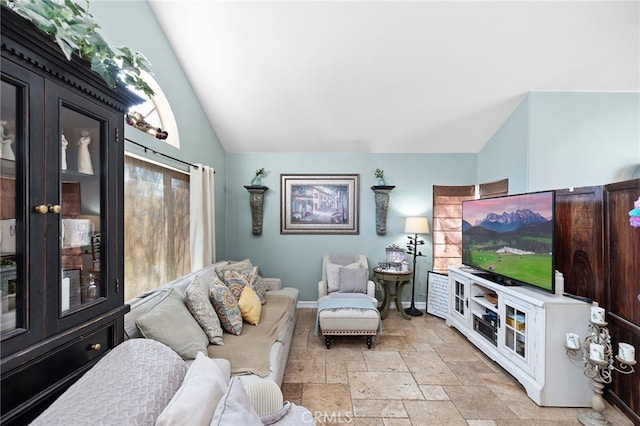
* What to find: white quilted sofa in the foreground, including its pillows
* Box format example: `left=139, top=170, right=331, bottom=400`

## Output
left=32, top=339, right=315, bottom=426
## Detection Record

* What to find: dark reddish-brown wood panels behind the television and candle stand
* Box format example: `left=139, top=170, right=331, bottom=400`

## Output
left=555, top=179, right=640, bottom=425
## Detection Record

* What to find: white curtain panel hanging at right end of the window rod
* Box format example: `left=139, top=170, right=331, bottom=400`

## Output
left=189, top=164, right=216, bottom=271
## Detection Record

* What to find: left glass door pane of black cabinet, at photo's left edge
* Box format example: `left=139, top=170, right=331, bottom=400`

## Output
left=0, top=80, right=24, bottom=334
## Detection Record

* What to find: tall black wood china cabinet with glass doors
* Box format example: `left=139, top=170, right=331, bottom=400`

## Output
left=0, top=7, right=140, bottom=424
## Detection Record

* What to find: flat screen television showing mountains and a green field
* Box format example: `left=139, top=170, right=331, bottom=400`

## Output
left=462, top=191, right=555, bottom=293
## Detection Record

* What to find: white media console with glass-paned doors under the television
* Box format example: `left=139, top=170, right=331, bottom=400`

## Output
left=446, top=267, right=593, bottom=407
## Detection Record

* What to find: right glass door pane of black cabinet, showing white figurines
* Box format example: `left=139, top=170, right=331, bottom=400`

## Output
left=59, top=105, right=104, bottom=315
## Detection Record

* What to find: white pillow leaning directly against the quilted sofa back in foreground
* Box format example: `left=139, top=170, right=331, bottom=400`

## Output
left=156, top=352, right=227, bottom=426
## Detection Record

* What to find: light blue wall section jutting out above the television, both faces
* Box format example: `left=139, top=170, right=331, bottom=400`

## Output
left=478, top=92, right=640, bottom=194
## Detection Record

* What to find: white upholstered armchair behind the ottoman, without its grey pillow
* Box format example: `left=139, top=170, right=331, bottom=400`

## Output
left=318, top=254, right=378, bottom=306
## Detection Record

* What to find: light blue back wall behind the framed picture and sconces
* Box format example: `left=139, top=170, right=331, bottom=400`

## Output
left=226, top=153, right=476, bottom=302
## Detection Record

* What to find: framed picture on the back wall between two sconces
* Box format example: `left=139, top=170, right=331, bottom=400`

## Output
left=280, top=174, right=360, bottom=234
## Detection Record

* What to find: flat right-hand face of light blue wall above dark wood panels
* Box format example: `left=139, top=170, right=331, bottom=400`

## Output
left=529, top=92, right=640, bottom=191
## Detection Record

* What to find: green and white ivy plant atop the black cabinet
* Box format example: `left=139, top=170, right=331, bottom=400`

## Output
left=1, top=0, right=153, bottom=96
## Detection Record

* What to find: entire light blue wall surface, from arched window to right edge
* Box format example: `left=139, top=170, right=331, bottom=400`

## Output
left=91, top=5, right=640, bottom=302
